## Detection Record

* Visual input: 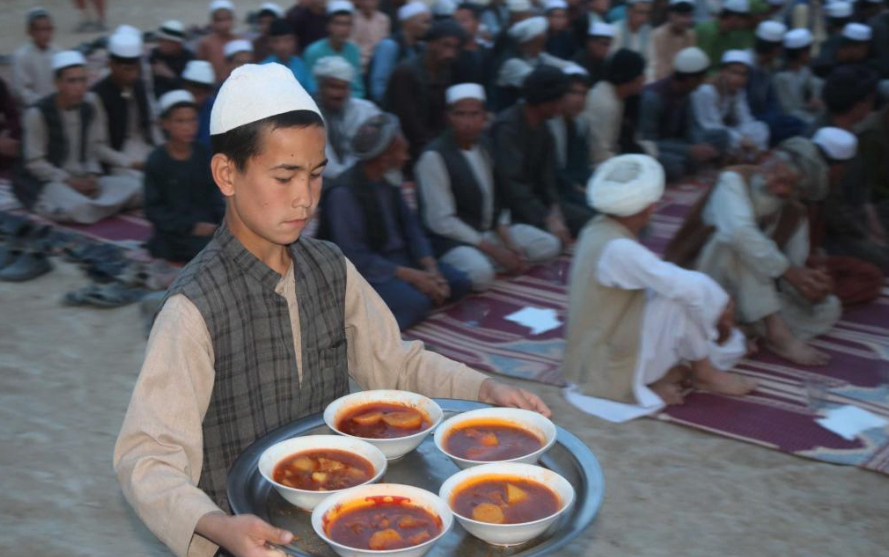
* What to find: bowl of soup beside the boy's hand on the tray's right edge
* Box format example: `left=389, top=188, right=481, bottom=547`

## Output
left=435, top=408, right=556, bottom=468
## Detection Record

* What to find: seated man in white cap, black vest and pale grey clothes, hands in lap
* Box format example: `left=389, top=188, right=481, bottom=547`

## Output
left=416, top=83, right=560, bottom=290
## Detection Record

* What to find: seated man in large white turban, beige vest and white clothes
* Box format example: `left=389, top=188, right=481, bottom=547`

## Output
left=562, top=155, right=756, bottom=421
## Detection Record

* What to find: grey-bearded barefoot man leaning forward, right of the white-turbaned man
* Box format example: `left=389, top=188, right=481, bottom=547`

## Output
left=667, top=151, right=842, bottom=365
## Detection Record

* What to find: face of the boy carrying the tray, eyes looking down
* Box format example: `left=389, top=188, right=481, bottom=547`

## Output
left=219, top=126, right=327, bottom=246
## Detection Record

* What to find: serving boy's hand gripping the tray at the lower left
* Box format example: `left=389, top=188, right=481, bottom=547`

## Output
left=195, top=511, right=293, bottom=557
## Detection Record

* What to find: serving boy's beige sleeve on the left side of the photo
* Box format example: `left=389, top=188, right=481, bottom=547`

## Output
left=114, top=295, right=220, bottom=557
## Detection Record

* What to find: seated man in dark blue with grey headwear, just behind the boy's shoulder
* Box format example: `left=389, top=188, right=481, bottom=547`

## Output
left=320, top=113, right=472, bottom=330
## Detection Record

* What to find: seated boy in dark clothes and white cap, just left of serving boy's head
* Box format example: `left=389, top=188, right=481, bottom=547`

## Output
left=145, top=89, right=225, bottom=262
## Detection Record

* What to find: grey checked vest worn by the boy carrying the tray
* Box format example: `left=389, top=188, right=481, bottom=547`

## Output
left=167, top=225, right=349, bottom=510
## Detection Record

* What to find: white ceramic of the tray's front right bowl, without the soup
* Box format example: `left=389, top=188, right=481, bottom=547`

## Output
left=438, top=462, right=574, bottom=546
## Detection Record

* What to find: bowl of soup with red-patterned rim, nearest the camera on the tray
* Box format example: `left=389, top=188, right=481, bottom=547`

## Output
left=312, top=484, right=454, bottom=557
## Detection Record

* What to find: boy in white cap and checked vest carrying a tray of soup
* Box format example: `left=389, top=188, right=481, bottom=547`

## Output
left=114, top=60, right=549, bottom=557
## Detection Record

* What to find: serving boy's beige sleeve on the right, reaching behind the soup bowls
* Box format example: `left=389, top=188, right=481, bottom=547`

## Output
left=346, top=261, right=487, bottom=400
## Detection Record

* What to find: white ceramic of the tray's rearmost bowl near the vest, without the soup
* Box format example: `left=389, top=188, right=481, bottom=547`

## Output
left=324, top=389, right=442, bottom=460
